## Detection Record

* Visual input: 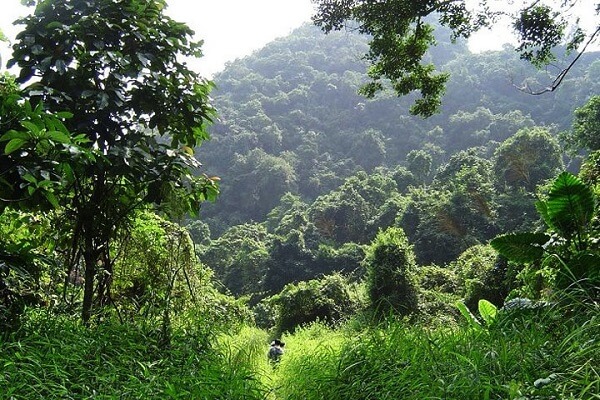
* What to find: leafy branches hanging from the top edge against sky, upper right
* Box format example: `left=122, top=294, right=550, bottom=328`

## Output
left=313, top=0, right=600, bottom=117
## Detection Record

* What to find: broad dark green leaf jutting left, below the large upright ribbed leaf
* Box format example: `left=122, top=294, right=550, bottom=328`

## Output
left=490, top=233, right=550, bottom=263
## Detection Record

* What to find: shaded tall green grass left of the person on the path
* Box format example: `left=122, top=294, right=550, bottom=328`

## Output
left=0, top=315, right=267, bottom=399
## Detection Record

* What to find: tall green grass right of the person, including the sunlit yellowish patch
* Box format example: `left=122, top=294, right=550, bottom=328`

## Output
left=277, top=296, right=600, bottom=400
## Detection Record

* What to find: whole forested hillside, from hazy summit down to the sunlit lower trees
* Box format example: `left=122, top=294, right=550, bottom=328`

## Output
left=190, top=26, right=600, bottom=305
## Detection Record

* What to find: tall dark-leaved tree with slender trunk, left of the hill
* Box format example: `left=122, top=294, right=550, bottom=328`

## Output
left=9, top=0, right=217, bottom=321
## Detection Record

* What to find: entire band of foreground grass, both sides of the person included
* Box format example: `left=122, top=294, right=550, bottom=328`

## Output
left=0, top=292, right=600, bottom=400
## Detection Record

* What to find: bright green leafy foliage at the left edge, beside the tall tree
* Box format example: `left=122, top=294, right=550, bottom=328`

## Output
left=0, top=73, right=91, bottom=211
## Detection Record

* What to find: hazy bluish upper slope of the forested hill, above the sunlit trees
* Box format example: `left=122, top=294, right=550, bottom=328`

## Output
left=203, top=26, right=600, bottom=234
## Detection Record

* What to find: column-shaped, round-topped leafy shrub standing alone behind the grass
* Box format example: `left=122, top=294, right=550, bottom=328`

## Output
left=365, top=227, right=417, bottom=315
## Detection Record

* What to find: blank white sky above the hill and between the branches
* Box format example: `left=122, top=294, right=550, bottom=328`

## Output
left=0, top=0, right=597, bottom=77
